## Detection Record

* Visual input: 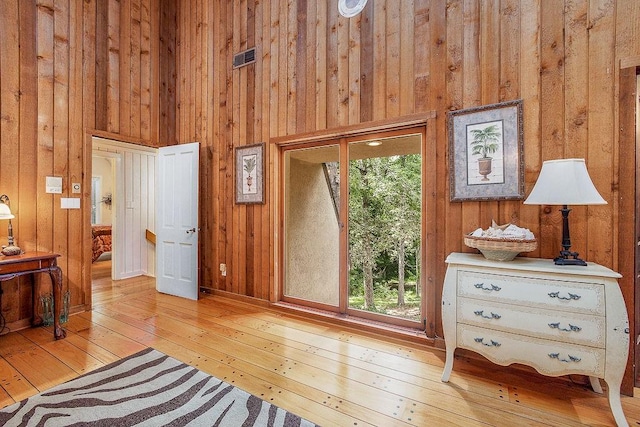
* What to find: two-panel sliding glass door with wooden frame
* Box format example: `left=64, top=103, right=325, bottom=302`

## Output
left=282, top=132, right=425, bottom=328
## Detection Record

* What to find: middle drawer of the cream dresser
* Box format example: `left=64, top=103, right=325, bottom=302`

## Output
left=457, top=298, right=605, bottom=348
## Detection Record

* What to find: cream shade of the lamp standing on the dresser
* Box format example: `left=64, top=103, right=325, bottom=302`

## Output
left=524, top=159, right=607, bottom=205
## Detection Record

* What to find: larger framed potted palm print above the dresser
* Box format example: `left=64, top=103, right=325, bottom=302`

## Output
left=447, top=99, right=524, bottom=202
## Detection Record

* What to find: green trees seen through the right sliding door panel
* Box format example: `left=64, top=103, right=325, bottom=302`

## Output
left=349, top=154, right=422, bottom=320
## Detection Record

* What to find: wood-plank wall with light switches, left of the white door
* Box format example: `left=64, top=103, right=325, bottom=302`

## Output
left=0, top=0, right=175, bottom=327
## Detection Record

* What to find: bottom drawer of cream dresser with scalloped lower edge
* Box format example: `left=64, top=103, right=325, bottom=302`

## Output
left=457, top=325, right=605, bottom=377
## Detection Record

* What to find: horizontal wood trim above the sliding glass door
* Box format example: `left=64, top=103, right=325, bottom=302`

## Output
left=270, top=111, right=436, bottom=146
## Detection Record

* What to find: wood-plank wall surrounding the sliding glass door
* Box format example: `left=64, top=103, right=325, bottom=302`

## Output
left=176, top=0, right=640, bottom=314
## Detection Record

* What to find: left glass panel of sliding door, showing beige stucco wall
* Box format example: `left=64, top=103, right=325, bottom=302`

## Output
left=284, top=145, right=340, bottom=308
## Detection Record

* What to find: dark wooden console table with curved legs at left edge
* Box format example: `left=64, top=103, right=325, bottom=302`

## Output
left=0, top=252, right=67, bottom=339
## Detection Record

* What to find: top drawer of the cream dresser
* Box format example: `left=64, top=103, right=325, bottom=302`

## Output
left=457, top=270, right=605, bottom=316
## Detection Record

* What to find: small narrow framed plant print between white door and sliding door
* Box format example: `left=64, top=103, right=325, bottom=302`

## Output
left=235, top=142, right=264, bottom=204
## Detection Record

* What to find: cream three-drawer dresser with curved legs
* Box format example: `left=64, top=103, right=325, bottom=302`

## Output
left=442, top=253, right=629, bottom=426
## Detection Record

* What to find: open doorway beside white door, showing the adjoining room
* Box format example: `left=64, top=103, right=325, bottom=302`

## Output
left=91, top=137, right=157, bottom=290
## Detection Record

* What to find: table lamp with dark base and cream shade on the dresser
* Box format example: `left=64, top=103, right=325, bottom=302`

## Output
left=524, top=159, right=607, bottom=265
